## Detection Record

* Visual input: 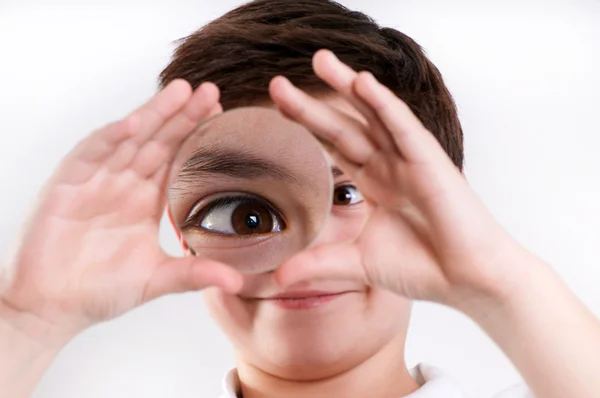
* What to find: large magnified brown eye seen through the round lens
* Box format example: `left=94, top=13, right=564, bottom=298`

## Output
left=186, top=195, right=286, bottom=235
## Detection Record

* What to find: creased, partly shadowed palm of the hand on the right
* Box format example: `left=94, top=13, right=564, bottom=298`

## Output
left=356, top=154, right=504, bottom=299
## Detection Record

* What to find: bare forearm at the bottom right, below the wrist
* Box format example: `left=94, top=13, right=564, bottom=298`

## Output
left=468, top=258, right=600, bottom=398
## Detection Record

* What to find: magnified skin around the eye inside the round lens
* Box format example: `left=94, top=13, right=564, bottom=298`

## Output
left=169, top=107, right=332, bottom=273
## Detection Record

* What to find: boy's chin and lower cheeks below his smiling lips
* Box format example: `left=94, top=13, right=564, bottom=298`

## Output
left=207, top=291, right=410, bottom=380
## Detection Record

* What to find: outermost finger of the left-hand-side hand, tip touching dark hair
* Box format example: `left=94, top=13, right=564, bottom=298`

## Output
left=133, top=79, right=192, bottom=145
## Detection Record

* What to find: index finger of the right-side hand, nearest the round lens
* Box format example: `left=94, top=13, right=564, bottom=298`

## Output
left=269, top=76, right=376, bottom=164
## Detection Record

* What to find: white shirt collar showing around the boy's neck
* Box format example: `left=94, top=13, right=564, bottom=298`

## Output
left=219, top=364, right=533, bottom=398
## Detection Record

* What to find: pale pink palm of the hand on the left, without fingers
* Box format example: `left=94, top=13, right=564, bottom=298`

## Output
left=16, top=169, right=165, bottom=321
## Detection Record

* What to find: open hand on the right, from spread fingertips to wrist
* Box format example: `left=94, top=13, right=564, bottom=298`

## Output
left=270, top=50, right=528, bottom=307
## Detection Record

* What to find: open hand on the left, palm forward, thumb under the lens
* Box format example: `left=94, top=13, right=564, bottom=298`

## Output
left=0, top=80, right=242, bottom=343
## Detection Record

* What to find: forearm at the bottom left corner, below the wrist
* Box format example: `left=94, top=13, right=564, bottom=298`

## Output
left=0, top=309, right=62, bottom=398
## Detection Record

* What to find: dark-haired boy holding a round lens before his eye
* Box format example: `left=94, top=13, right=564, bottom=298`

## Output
left=0, top=0, right=600, bottom=398
